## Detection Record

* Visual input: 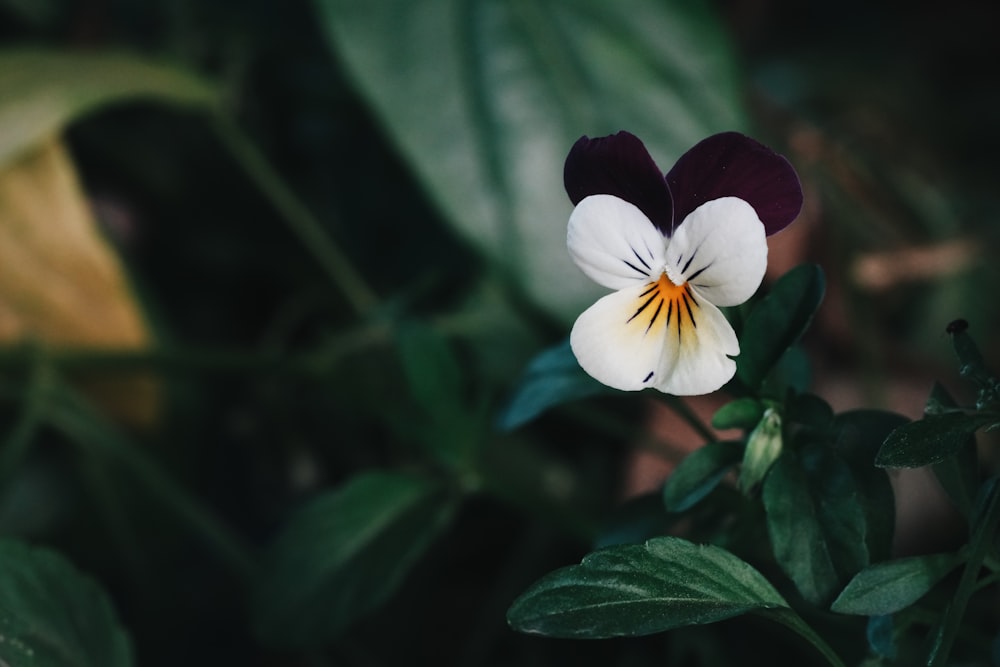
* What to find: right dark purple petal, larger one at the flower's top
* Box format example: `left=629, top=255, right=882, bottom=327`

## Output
left=667, top=132, right=802, bottom=236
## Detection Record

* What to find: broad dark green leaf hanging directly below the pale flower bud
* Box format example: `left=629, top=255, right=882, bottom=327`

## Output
left=763, top=444, right=868, bottom=605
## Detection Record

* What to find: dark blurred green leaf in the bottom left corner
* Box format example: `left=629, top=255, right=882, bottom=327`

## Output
left=0, top=540, right=133, bottom=667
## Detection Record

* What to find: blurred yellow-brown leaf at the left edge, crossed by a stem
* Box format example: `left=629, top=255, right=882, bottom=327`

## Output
left=0, top=136, right=159, bottom=425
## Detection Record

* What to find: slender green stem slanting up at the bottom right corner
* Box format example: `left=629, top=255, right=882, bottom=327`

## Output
left=927, top=478, right=1000, bottom=667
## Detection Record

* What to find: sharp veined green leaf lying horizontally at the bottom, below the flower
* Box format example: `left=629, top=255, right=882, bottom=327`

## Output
left=507, top=537, right=788, bottom=639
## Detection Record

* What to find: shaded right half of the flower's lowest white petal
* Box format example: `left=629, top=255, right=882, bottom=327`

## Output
left=656, top=290, right=740, bottom=396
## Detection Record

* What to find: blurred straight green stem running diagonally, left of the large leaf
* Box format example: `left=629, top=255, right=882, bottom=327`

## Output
left=216, top=115, right=379, bottom=316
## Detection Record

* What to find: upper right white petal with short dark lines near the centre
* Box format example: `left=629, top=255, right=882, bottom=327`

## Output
left=668, top=197, right=767, bottom=306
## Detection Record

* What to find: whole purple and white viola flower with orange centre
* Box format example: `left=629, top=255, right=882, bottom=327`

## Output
left=564, top=132, right=802, bottom=395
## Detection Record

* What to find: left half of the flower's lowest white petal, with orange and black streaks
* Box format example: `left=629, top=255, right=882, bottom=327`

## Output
left=569, top=282, right=677, bottom=391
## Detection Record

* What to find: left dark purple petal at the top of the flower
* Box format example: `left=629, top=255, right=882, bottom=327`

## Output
left=563, top=132, right=673, bottom=233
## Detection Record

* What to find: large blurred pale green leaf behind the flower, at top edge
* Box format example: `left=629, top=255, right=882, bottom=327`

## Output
left=316, top=0, right=746, bottom=321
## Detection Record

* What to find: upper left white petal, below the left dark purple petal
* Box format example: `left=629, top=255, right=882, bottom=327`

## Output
left=566, top=195, right=665, bottom=289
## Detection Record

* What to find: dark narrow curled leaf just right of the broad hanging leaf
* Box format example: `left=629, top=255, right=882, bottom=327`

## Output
left=832, top=410, right=908, bottom=561
